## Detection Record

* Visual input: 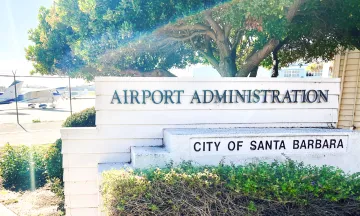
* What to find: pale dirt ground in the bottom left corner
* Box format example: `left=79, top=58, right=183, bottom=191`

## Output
left=0, top=186, right=62, bottom=216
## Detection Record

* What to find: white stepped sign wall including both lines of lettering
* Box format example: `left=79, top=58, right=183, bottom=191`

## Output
left=61, top=77, right=360, bottom=215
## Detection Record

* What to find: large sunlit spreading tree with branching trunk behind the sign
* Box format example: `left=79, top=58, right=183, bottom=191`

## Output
left=27, top=0, right=356, bottom=79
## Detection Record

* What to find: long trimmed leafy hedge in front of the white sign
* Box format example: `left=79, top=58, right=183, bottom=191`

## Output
left=102, top=161, right=360, bottom=215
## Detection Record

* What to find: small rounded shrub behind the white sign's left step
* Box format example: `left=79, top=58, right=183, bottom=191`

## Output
left=63, top=107, right=96, bottom=127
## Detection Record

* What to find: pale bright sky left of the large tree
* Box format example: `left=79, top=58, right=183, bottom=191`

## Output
left=0, top=0, right=83, bottom=87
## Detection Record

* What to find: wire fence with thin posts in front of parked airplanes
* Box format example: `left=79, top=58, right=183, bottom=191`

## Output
left=0, top=72, right=95, bottom=146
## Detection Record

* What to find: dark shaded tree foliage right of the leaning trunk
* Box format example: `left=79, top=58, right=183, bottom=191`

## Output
left=262, top=0, right=360, bottom=77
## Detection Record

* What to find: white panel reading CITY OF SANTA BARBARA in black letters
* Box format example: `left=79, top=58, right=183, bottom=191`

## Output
left=190, top=135, right=348, bottom=156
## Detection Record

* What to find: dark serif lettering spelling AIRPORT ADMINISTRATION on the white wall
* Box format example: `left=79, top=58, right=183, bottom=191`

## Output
left=110, top=89, right=329, bottom=104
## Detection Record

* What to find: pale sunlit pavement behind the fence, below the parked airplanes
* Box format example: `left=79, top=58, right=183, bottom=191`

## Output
left=0, top=99, right=95, bottom=146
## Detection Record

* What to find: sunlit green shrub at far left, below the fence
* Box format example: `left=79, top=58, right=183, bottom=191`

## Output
left=0, top=144, right=46, bottom=190
